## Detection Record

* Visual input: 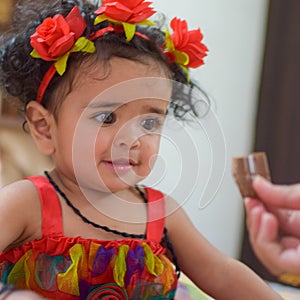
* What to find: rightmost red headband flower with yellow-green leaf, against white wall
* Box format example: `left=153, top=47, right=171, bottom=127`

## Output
left=166, top=18, right=208, bottom=68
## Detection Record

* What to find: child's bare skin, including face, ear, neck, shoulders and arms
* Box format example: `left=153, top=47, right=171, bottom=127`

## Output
left=0, top=58, right=281, bottom=300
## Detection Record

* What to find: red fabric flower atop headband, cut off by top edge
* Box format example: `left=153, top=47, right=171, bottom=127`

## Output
left=95, top=0, right=155, bottom=24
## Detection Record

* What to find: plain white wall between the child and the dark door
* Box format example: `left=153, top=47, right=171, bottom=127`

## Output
left=143, top=0, right=268, bottom=257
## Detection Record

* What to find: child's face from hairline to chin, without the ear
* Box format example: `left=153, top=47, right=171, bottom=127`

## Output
left=54, top=58, right=171, bottom=192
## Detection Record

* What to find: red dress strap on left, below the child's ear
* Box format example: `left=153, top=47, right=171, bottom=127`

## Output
left=25, top=176, right=63, bottom=236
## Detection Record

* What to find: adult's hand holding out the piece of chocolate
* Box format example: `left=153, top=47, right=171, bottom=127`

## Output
left=245, top=177, right=300, bottom=275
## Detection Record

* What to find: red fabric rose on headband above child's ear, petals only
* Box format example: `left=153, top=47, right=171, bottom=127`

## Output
left=30, top=6, right=86, bottom=61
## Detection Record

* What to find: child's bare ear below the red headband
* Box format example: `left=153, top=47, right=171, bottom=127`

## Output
left=26, top=101, right=55, bottom=155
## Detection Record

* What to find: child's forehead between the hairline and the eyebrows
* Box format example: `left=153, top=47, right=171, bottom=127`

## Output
left=72, top=58, right=173, bottom=95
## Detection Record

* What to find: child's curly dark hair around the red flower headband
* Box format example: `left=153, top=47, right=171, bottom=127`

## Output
left=0, top=0, right=209, bottom=119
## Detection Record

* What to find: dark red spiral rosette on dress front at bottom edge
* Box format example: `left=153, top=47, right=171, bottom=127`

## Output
left=86, top=283, right=128, bottom=300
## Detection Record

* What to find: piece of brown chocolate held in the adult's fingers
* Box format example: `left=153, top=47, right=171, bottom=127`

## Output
left=232, top=152, right=270, bottom=198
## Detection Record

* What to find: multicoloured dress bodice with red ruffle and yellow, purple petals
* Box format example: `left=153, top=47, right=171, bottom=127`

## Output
left=0, top=237, right=177, bottom=299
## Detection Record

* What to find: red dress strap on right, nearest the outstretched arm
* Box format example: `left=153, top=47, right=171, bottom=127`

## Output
left=145, top=187, right=165, bottom=243
